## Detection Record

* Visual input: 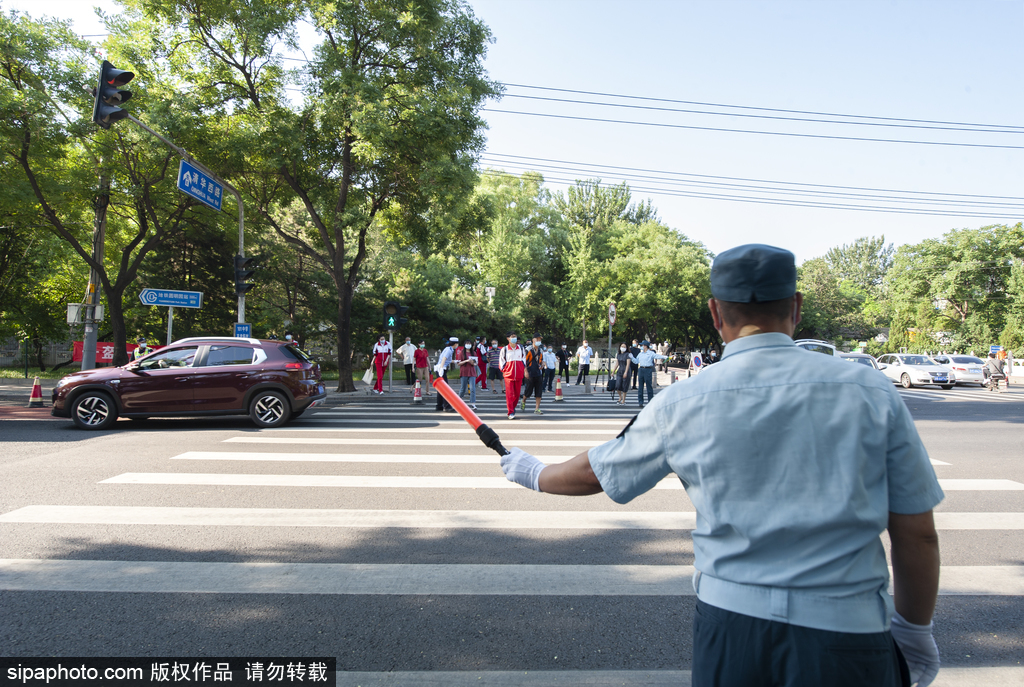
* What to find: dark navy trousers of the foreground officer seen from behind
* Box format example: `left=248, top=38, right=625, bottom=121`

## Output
left=690, top=600, right=910, bottom=687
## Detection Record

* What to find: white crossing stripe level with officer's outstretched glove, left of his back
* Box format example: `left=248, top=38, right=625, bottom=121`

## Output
left=99, top=473, right=683, bottom=491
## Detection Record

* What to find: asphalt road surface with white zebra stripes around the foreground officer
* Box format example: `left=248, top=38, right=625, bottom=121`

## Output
left=0, top=380, right=1024, bottom=685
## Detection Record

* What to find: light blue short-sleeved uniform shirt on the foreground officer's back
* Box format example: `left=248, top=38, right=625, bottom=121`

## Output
left=590, top=333, right=944, bottom=633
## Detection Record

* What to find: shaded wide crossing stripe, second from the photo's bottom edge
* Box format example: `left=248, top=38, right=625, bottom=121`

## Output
left=0, top=558, right=1024, bottom=597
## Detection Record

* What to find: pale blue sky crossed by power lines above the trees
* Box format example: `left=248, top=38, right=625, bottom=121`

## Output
left=9, top=0, right=1024, bottom=260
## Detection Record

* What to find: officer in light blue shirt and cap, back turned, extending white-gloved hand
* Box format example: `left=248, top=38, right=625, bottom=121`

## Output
left=502, top=245, right=943, bottom=687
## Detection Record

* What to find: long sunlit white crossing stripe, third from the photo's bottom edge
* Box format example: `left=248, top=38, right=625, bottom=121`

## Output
left=8, top=506, right=1024, bottom=531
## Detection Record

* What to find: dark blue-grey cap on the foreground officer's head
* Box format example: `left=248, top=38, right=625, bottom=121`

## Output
left=711, top=244, right=797, bottom=303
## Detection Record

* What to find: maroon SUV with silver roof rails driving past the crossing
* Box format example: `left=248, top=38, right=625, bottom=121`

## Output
left=52, top=337, right=327, bottom=429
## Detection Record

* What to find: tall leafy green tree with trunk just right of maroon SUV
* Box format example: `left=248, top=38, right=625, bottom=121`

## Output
left=130, top=0, right=497, bottom=391
